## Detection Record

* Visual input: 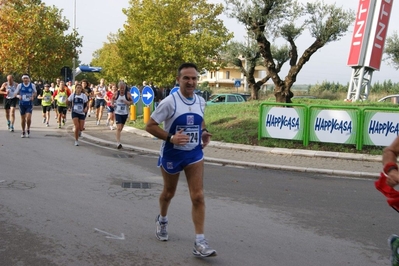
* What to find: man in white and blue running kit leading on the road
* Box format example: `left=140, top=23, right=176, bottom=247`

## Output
left=146, top=63, right=216, bottom=257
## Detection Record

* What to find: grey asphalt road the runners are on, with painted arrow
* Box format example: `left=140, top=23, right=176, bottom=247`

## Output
left=0, top=111, right=399, bottom=266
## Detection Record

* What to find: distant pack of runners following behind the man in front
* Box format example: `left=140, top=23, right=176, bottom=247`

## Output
left=0, top=74, right=133, bottom=149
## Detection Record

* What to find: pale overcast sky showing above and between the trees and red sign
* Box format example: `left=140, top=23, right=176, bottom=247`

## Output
left=43, top=0, right=399, bottom=84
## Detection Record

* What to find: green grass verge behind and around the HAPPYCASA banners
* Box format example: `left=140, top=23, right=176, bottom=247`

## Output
left=128, top=99, right=397, bottom=155
